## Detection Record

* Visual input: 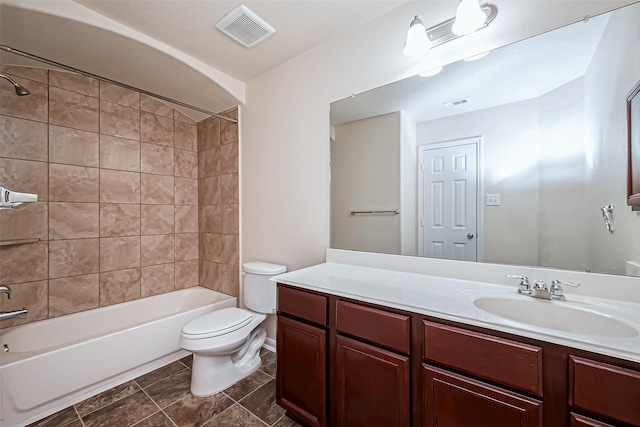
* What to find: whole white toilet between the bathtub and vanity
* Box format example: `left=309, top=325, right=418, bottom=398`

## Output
left=180, top=262, right=287, bottom=396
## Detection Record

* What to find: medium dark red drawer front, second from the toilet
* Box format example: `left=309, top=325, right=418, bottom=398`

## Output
left=336, top=301, right=411, bottom=354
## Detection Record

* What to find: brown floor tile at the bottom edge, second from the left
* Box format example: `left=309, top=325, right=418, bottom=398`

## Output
left=82, top=391, right=158, bottom=427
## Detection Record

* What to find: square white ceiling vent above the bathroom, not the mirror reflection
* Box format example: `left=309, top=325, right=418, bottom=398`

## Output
left=216, top=5, right=276, bottom=47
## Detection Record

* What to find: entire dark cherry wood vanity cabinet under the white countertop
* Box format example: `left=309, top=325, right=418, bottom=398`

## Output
left=276, top=285, right=640, bottom=427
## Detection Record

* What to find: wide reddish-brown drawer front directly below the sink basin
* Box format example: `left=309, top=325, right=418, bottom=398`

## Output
left=424, top=321, right=542, bottom=396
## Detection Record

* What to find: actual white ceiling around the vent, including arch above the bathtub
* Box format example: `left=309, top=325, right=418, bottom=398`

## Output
left=0, top=0, right=406, bottom=120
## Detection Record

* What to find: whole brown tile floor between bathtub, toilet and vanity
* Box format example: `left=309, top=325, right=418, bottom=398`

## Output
left=29, top=349, right=301, bottom=427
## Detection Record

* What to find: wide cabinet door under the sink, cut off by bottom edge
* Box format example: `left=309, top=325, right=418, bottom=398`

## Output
left=422, top=365, right=542, bottom=427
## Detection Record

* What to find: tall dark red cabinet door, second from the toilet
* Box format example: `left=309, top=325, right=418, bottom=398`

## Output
left=336, top=336, right=410, bottom=427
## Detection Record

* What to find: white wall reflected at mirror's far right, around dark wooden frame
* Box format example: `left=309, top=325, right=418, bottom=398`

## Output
left=585, top=4, right=640, bottom=274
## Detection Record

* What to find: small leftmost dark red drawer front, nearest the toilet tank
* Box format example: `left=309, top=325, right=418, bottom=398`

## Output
left=278, top=285, right=327, bottom=326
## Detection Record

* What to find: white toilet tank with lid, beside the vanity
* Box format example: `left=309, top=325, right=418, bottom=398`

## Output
left=242, top=261, right=287, bottom=314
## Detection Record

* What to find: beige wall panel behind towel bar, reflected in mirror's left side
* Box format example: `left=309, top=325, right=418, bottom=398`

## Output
left=331, top=112, right=401, bottom=253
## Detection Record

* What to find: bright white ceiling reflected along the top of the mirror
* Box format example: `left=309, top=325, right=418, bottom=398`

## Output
left=331, top=6, right=608, bottom=126
